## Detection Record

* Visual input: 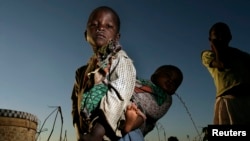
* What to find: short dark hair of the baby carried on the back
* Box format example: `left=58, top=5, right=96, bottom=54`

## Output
left=151, top=65, right=183, bottom=87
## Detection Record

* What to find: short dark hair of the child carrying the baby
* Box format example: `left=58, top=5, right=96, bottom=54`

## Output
left=88, top=6, right=121, bottom=33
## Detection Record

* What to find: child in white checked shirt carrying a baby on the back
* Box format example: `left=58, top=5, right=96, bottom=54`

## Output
left=71, top=6, right=136, bottom=141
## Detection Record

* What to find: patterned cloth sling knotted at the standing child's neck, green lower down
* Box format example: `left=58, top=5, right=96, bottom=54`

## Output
left=81, top=41, right=121, bottom=117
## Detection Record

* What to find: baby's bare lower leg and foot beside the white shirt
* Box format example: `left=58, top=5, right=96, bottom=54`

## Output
left=124, top=103, right=146, bottom=133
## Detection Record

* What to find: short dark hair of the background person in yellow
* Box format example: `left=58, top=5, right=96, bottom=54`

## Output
left=209, top=22, right=232, bottom=41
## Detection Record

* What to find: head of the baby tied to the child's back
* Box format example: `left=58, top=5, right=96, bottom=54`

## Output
left=151, top=65, right=183, bottom=95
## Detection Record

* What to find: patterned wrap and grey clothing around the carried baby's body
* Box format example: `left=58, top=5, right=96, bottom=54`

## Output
left=132, top=78, right=172, bottom=136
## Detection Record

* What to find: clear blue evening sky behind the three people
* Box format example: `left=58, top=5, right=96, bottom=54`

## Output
left=0, top=0, right=250, bottom=141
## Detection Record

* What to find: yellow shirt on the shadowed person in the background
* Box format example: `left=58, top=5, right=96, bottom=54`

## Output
left=201, top=47, right=250, bottom=97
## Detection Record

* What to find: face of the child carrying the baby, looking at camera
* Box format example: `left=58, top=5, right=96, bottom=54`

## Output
left=85, top=9, right=119, bottom=51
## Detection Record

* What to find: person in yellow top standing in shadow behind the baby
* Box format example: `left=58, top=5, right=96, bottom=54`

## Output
left=201, top=22, right=250, bottom=125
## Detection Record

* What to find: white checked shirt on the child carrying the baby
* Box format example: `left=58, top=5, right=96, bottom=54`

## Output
left=100, top=50, right=136, bottom=136
